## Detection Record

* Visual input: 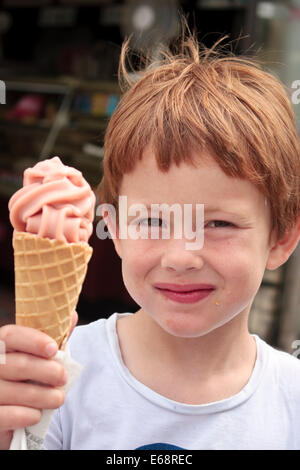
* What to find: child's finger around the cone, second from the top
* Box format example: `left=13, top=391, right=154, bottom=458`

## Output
left=0, top=352, right=67, bottom=387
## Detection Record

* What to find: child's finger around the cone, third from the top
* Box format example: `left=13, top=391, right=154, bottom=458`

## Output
left=0, top=380, right=65, bottom=410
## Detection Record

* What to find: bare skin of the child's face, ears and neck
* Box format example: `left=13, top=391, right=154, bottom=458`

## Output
left=106, top=148, right=300, bottom=404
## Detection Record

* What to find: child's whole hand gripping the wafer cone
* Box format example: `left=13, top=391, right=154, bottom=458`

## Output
left=0, top=312, right=78, bottom=450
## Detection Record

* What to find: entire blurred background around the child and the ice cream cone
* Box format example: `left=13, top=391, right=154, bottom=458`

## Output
left=0, top=0, right=300, bottom=355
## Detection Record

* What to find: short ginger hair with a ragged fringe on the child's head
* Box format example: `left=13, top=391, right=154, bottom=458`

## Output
left=98, top=35, right=300, bottom=238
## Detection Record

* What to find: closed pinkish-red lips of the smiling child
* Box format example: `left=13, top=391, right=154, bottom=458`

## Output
left=154, top=283, right=216, bottom=303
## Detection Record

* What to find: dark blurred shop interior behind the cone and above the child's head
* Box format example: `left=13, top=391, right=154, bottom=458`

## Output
left=0, top=0, right=256, bottom=323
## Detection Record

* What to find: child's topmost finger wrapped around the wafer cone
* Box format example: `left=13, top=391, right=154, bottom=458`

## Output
left=0, top=325, right=58, bottom=357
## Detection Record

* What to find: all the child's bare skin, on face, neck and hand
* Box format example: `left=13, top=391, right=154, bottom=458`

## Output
left=0, top=149, right=300, bottom=449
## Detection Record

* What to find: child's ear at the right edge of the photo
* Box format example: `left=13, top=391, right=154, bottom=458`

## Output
left=266, top=217, right=300, bottom=270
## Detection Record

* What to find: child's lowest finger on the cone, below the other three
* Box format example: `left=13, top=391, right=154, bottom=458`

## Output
left=0, top=406, right=42, bottom=431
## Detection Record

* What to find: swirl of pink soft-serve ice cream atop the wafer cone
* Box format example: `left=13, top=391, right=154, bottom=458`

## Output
left=8, top=157, right=96, bottom=243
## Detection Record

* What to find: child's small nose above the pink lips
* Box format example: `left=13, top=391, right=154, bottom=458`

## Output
left=161, top=240, right=204, bottom=272
